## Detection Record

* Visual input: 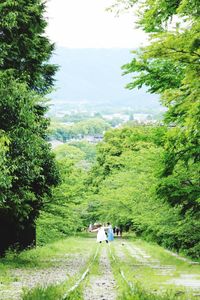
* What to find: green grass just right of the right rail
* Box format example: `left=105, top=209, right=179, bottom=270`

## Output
left=110, top=244, right=197, bottom=300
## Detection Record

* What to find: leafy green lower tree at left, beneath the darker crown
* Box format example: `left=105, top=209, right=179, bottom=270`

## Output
left=0, top=73, right=58, bottom=222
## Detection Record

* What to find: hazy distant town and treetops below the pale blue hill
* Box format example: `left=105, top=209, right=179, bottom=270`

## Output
left=48, top=101, right=164, bottom=148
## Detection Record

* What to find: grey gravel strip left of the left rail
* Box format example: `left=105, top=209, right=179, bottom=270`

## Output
left=0, top=254, right=88, bottom=300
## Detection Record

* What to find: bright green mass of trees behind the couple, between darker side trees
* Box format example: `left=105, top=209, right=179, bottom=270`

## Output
left=38, top=117, right=199, bottom=257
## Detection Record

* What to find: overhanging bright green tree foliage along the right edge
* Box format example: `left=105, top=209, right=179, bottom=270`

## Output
left=106, top=0, right=200, bottom=256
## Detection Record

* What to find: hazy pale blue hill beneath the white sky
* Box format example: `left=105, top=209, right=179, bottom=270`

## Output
left=51, top=48, right=160, bottom=109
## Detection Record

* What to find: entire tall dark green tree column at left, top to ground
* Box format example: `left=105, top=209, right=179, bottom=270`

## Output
left=0, top=0, right=58, bottom=253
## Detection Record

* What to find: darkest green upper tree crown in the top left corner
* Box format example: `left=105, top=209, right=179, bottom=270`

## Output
left=0, top=0, right=57, bottom=93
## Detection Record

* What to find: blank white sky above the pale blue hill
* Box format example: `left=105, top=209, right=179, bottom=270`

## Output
left=47, top=0, right=146, bottom=49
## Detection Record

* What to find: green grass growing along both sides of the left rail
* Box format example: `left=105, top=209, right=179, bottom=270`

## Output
left=22, top=245, right=99, bottom=300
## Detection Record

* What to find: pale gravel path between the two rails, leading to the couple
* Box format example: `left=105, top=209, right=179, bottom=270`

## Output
left=84, top=245, right=116, bottom=300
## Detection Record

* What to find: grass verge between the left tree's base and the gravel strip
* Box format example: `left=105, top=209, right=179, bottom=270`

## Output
left=0, top=237, right=96, bottom=299
